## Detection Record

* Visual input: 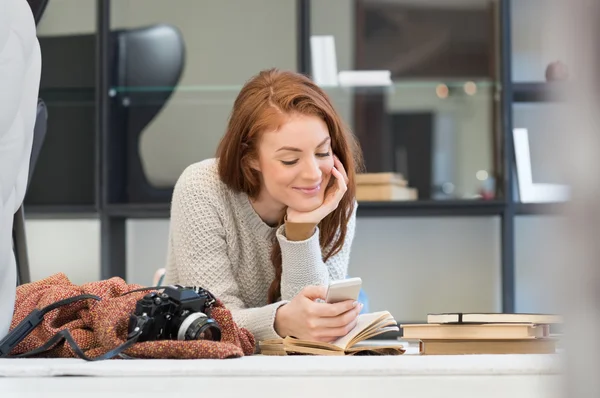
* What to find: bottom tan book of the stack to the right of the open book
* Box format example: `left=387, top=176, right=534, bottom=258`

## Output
left=419, top=338, right=557, bottom=355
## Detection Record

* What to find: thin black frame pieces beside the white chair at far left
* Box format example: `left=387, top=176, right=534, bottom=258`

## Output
left=13, top=99, right=48, bottom=284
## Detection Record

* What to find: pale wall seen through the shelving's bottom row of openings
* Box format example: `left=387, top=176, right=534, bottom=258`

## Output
left=27, top=211, right=568, bottom=320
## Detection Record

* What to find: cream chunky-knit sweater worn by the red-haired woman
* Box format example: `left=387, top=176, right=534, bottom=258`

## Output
left=165, top=159, right=356, bottom=341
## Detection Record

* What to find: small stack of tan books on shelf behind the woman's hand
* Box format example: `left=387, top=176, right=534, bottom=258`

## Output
left=356, top=173, right=418, bottom=202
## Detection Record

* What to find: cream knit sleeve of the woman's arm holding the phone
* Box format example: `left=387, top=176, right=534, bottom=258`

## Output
left=165, top=172, right=287, bottom=341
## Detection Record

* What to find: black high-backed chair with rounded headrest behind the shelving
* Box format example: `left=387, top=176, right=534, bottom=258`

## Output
left=105, top=24, right=185, bottom=203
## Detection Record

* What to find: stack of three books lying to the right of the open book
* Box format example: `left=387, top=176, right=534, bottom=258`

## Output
left=401, top=313, right=562, bottom=355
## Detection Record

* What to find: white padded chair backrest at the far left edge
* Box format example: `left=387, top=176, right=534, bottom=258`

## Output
left=0, top=0, right=41, bottom=338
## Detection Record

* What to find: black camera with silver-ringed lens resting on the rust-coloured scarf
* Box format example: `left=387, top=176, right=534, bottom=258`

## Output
left=128, top=285, right=221, bottom=342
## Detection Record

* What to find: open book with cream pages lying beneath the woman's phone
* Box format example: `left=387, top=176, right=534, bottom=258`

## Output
left=259, top=311, right=405, bottom=355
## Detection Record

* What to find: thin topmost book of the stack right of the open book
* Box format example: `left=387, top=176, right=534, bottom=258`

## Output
left=427, top=312, right=562, bottom=324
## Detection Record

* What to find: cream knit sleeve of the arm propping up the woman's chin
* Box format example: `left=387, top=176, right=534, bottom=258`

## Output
left=277, top=203, right=358, bottom=300
